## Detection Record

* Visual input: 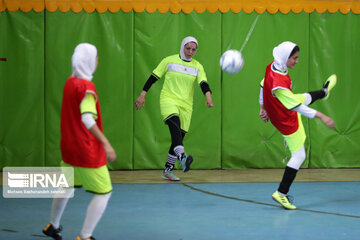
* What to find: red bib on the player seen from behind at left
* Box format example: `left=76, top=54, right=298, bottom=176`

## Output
left=60, top=76, right=107, bottom=168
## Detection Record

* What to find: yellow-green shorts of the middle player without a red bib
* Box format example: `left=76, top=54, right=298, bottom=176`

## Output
left=160, top=98, right=192, bottom=132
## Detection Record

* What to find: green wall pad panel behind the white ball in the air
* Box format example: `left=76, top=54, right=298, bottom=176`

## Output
left=222, top=12, right=309, bottom=169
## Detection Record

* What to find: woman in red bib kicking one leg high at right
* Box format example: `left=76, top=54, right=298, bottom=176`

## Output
left=259, top=41, right=337, bottom=209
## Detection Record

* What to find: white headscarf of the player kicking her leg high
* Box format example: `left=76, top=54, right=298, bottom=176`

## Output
left=273, top=41, right=296, bottom=72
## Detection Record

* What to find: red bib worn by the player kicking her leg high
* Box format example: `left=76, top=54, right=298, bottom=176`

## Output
left=263, top=63, right=299, bottom=135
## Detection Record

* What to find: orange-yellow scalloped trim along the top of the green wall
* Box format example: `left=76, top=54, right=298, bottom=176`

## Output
left=0, top=0, right=360, bottom=14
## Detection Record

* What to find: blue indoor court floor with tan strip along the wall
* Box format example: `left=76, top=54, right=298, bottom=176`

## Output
left=0, top=169, right=360, bottom=240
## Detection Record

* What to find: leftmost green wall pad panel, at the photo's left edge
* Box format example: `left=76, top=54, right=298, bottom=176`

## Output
left=0, top=11, right=45, bottom=168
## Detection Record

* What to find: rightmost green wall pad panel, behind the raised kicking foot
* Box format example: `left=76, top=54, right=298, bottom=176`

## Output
left=309, top=12, right=360, bottom=168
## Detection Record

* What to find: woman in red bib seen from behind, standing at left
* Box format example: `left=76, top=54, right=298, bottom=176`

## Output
left=43, top=43, right=116, bottom=240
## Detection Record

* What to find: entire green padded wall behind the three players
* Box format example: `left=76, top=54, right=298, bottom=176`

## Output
left=0, top=11, right=360, bottom=169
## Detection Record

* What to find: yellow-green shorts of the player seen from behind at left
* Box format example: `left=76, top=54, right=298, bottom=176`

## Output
left=60, top=161, right=112, bottom=194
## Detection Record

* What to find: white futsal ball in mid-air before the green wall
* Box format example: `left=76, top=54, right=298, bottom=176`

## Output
left=220, top=49, right=244, bottom=74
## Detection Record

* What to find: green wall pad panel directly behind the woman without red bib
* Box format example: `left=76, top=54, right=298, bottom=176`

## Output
left=134, top=12, right=221, bottom=169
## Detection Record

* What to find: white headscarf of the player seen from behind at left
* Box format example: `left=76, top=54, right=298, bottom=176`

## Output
left=71, top=43, right=97, bottom=81
